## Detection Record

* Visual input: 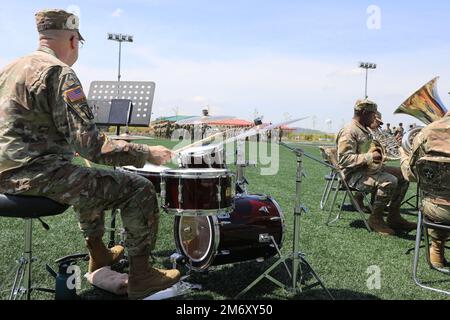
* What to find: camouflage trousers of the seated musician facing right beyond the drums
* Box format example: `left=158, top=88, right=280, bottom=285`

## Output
left=347, top=166, right=409, bottom=209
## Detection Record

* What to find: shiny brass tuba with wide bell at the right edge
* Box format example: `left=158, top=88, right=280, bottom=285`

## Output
left=394, top=77, right=447, bottom=153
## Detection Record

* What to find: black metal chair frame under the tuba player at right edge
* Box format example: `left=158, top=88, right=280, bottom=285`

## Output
left=413, top=210, right=450, bottom=295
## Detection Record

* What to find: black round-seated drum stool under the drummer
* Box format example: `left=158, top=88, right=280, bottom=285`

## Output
left=0, top=194, right=68, bottom=300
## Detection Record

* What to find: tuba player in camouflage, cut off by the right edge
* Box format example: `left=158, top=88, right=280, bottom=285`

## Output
left=400, top=112, right=450, bottom=268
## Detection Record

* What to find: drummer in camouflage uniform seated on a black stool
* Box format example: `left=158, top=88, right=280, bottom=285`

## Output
left=0, top=9, right=180, bottom=299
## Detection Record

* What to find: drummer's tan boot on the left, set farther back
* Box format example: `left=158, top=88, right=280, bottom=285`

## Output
left=86, top=237, right=124, bottom=272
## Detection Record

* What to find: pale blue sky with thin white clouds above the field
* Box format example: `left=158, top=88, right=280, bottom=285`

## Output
left=0, top=0, right=450, bottom=131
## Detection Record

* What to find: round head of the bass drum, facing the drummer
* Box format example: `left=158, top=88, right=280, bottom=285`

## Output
left=177, top=217, right=214, bottom=265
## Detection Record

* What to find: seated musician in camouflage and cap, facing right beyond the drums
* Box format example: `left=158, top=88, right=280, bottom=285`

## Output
left=336, top=99, right=416, bottom=235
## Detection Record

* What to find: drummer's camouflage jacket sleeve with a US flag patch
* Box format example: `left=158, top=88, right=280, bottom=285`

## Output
left=48, top=67, right=149, bottom=168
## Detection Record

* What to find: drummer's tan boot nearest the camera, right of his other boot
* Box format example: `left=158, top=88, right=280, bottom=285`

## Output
left=128, top=255, right=181, bottom=300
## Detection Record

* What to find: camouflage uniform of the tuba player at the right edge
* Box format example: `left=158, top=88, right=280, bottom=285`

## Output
left=401, top=112, right=450, bottom=240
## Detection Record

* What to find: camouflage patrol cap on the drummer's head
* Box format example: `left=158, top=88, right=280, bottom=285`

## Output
left=35, top=9, right=84, bottom=40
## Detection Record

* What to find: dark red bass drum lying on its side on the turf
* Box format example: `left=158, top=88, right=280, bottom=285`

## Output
left=174, top=195, right=285, bottom=271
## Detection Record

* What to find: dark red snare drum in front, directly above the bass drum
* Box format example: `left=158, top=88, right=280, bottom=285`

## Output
left=161, top=169, right=234, bottom=216
